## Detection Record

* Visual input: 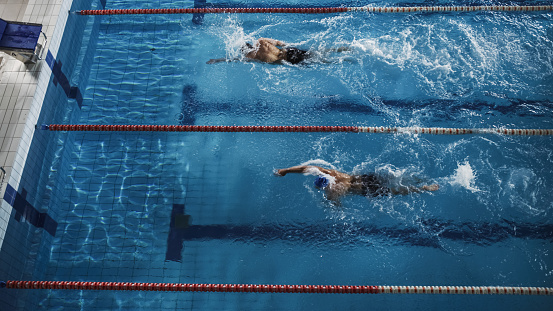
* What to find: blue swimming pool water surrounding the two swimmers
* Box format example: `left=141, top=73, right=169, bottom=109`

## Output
left=0, top=1, right=553, bottom=310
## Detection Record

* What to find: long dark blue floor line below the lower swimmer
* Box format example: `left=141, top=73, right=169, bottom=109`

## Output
left=179, top=219, right=553, bottom=249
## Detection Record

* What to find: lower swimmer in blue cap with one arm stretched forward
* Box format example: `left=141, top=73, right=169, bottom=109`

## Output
left=275, top=165, right=440, bottom=203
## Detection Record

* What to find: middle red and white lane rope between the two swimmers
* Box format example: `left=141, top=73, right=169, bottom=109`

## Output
left=40, top=124, right=553, bottom=136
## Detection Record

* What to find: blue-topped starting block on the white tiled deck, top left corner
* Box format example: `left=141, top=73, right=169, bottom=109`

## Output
left=0, top=18, right=48, bottom=64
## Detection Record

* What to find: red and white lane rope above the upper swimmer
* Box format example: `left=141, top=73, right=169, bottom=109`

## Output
left=76, top=5, right=553, bottom=15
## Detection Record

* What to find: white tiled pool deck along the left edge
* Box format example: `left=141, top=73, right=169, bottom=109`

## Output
left=0, top=0, right=71, bottom=248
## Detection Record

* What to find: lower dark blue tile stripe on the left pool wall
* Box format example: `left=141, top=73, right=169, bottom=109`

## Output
left=4, top=184, right=58, bottom=236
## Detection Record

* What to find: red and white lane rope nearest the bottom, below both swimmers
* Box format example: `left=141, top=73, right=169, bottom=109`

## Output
left=0, top=281, right=553, bottom=296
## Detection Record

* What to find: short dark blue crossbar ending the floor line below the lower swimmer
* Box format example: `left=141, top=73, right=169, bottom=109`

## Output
left=165, top=204, right=190, bottom=261
